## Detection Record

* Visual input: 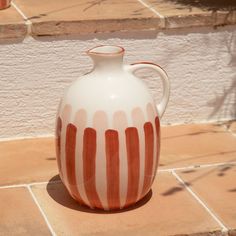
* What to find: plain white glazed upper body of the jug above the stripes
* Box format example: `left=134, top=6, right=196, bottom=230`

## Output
left=59, top=46, right=158, bottom=125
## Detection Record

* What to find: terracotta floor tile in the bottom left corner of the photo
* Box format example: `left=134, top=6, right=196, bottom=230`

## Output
left=0, top=188, right=50, bottom=236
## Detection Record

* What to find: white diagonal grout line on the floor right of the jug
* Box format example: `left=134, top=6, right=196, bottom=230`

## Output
left=171, top=170, right=229, bottom=232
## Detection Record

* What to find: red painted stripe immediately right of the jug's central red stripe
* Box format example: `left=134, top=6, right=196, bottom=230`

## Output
left=125, top=127, right=140, bottom=206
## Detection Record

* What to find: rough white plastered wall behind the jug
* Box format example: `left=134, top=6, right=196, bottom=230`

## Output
left=0, top=26, right=236, bottom=139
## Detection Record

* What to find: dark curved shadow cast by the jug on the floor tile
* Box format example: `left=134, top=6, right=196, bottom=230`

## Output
left=47, top=175, right=152, bottom=214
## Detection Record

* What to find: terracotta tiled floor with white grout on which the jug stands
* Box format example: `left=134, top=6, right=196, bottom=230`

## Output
left=0, top=122, right=236, bottom=236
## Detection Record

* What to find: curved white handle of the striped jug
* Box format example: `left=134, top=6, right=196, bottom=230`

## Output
left=127, top=62, right=170, bottom=118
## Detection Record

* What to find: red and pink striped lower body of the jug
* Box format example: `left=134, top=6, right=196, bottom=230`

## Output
left=56, top=103, right=160, bottom=210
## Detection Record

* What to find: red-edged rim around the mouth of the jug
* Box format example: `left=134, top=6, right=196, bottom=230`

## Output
left=87, top=45, right=125, bottom=56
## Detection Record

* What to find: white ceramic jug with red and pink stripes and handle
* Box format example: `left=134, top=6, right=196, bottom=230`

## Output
left=56, top=45, right=170, bottom=210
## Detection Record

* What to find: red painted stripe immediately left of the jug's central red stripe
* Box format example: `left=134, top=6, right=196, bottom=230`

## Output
left=83, top=128, right=103, bottom=208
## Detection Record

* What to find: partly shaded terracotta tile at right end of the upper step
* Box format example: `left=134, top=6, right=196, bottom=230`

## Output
left=147, top=0, right=236, bottom=28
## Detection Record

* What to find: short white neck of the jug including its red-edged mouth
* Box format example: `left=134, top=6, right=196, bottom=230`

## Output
left=87, top=46, right=124, bottom=73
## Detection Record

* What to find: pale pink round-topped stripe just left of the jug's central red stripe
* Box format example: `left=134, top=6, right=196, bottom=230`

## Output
left=93, top=111, right=108, bottom=210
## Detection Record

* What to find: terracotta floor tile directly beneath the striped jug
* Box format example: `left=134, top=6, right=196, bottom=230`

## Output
left=30, top=173, right=219, bottom=236
